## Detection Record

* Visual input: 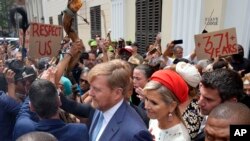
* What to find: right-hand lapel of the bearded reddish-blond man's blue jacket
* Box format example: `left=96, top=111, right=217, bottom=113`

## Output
left=99, top=102, right=128, bottom=141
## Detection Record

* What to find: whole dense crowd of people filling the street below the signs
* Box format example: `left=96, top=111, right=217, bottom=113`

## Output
left=0, top=33, right=250, bottom=141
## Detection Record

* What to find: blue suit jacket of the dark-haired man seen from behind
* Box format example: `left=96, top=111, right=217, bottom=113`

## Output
left=13, top=98, right=89, bottom=141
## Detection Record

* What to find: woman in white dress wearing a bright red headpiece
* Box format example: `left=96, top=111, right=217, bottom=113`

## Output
left=144, top=70, right=190, bottom=141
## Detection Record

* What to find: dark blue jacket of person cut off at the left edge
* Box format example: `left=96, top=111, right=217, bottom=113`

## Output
left=0, top=91, right=21, bottom=141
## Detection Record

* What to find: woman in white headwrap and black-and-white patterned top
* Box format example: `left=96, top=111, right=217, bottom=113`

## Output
left=175, top=62, right=203, bottom=139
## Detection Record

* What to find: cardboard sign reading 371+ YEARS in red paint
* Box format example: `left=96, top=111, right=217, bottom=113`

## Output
left=194, top=28, right=238, bottom=60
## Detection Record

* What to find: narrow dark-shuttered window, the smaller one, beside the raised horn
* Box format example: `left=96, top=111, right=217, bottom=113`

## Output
left=90, top=6, right=102, bottom=39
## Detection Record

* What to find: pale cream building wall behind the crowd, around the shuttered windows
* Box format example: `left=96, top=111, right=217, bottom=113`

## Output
left=23, top=0, right=250, bottom=56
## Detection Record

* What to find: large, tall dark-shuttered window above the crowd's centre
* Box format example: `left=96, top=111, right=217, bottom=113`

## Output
left=136, top=0, right=162, bottom=54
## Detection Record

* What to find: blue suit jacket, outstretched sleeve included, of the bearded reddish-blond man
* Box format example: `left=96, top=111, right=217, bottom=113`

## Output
left=61, top=95, right=152, bottom=141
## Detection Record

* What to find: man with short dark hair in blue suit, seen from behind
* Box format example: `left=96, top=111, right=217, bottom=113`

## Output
left=13, top=79, right=89, bottom=141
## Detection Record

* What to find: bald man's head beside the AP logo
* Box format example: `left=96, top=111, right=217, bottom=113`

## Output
left=205, top=102, right=250, bottom=141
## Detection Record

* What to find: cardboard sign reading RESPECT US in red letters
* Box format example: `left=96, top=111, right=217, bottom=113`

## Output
left=26, top=23, right=62, bottom=58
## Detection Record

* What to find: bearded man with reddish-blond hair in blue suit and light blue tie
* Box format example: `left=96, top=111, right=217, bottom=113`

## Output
left=61, top=60, right=152, bottom=141
